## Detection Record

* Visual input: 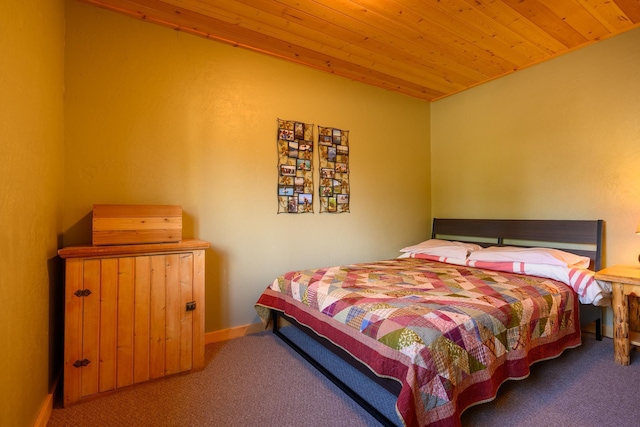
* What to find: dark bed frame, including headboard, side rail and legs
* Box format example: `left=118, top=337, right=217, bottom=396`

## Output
left=271, top=218, right=604, bottom=426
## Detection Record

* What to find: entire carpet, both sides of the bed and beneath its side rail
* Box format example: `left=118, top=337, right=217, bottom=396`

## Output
left=48, top=328, right=640, bottom=427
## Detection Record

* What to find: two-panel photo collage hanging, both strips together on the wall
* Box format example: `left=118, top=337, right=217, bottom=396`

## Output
left=277, top=119, right=349, bottom=213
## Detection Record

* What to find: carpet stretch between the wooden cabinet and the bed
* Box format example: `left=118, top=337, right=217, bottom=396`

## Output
left=48, top=332, right=388, bottom=427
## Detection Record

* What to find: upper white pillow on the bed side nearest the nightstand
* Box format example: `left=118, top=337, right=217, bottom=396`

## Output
left=469, top=246, right=591, bottom=268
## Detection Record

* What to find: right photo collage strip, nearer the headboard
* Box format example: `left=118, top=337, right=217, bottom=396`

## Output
left=318, top=126, right=350, bottom=213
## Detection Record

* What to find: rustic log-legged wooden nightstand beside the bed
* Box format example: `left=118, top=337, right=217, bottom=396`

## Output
left=596, top=265, right=640, bottom=366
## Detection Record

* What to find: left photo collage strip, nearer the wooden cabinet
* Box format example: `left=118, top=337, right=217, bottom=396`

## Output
left=277, top=119, right=313, bottom=213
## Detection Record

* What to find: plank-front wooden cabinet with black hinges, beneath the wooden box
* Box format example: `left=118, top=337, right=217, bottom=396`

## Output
left=58, top=240, right=209, bottom=406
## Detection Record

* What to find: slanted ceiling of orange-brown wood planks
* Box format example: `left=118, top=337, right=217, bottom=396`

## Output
left=82, top=0, right=640, bottom=101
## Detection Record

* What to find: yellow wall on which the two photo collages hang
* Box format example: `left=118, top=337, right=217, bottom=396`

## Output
left=64, top=2, right=430, bottom=331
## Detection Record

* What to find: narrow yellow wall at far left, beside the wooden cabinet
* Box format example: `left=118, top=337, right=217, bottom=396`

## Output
left=0, top=0, right=64, bottom=427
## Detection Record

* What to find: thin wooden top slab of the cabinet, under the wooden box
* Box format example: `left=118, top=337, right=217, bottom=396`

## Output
left=58, top=240, right=211, bottom=258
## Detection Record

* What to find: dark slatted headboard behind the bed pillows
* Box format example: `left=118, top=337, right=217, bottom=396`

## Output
left=431, top=218, right=604, bottom=271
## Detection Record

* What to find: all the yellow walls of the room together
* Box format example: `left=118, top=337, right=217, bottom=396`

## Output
left=7, top=0, right=640, bottom=426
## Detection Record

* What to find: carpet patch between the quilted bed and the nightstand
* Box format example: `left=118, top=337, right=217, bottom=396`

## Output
left=462, top=334, right=640, bottom=427
